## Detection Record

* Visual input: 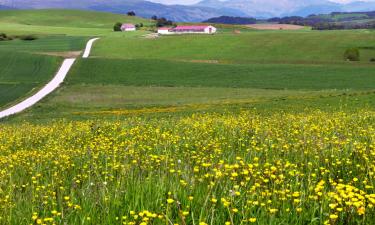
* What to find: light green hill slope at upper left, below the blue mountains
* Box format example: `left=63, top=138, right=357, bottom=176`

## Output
left=0, top=9, right=150, bottom=36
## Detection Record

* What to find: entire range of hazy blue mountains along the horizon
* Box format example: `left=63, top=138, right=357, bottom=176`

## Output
left=0, top=0, right=375, bottom=22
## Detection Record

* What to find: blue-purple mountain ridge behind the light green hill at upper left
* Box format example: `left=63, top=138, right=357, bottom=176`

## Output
left=0, top=0, right=246, bottom=22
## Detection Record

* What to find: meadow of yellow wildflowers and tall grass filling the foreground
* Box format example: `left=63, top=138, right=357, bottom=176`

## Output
left=0, top=111, right=375, bottom=225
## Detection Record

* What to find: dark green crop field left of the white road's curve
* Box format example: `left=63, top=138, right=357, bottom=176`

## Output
left=0, top=35, right=87, bottom=108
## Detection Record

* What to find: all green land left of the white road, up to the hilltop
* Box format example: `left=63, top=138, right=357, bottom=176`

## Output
left=0, top=10, right=148, bottom=108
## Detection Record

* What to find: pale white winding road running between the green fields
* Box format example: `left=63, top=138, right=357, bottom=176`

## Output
left=0, top=38, right=99, bottom=119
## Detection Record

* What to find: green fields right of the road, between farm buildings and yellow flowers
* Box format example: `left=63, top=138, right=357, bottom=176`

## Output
left=1, top=25, right=375, bottom=120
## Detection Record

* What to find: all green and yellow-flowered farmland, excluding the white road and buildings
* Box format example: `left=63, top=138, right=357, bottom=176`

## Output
left=0, top=10, right=375, bottom=225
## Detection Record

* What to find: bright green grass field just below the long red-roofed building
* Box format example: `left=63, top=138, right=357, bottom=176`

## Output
left=93, top=31, right=375, bottom=64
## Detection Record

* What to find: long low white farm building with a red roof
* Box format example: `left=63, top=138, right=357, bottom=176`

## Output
left=158, top=25, right=217, bottom=34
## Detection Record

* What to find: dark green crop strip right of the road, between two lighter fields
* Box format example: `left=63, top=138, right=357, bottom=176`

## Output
left=67, top=59, right=375, bottom=90
